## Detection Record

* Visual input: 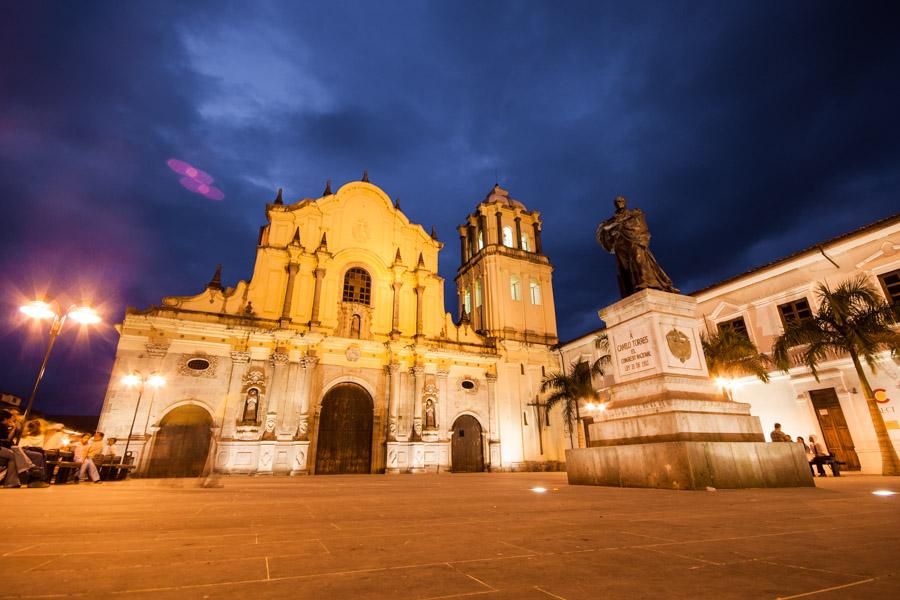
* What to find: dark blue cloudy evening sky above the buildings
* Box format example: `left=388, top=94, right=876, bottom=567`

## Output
left=0, top=1, right=900, bottom=413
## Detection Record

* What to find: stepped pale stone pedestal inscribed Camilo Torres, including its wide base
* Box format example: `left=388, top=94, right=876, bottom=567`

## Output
left=566, top=290, right=814, bottom=489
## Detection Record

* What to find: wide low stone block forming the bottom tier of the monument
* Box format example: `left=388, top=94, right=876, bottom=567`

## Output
left=566, top=442, right=815, bottom=490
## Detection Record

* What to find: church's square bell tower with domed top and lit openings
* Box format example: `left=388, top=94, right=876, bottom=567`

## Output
left=455, top=185, right=558, bottom=345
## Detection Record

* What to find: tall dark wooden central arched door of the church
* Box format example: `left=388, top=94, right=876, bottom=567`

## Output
left=316, top=383, right=374, bottom=475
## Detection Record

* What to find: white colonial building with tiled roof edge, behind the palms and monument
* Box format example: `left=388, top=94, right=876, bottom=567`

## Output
left=561, top=215, right=900, bottom=473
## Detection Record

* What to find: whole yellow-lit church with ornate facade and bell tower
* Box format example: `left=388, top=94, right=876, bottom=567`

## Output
left=99, top=176, right=566, bottom=476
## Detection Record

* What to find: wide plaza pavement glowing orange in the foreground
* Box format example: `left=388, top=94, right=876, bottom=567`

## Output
left=0, top=473, right=900, bottom=600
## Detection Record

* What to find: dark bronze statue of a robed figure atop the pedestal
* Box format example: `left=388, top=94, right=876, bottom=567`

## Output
left=596, top=196, right=678, bottom=298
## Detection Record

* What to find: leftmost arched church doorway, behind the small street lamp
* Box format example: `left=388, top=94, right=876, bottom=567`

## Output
left=147, top=404, right=212, bottom=477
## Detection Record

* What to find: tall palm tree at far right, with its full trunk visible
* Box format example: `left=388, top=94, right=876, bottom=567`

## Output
left=773, top=275, right=900, bottom=475
